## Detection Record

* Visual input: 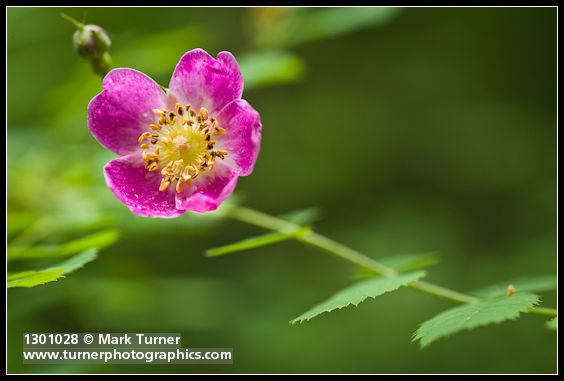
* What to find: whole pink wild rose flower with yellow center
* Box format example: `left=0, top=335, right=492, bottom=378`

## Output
left=88, top=49, right=262, bottom=218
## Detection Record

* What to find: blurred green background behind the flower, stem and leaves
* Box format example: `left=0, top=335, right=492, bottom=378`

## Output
left=7, top=8, right=557, bottom=373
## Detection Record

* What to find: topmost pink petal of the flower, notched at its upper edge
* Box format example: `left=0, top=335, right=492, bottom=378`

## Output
left=169, top=49, right=243, bottom=115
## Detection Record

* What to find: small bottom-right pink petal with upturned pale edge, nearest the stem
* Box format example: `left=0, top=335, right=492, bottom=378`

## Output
left=176, top=162, right=239, bottom=213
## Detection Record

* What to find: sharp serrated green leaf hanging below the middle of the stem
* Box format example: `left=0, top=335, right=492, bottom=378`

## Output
left=290, top=271, right=425, bottom=324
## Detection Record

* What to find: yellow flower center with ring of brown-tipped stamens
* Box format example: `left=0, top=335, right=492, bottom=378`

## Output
left=139, top=103, right=227, bottom=192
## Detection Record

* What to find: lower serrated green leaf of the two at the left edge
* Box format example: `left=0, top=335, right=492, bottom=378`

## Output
left=6, top=249, right=98, bottom=288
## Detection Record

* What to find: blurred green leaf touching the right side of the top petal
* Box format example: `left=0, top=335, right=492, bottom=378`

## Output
left=237, top=50, right=305, bottom=90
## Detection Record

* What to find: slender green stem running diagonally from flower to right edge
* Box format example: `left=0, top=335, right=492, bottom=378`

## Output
left=227, top=206, right=557, bottom=316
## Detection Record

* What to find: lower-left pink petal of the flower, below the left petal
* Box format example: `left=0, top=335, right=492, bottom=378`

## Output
left=104, top=151, right=184, bottom=218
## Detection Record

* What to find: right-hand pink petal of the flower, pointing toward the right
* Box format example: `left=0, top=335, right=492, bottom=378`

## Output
left=217, top=99, right=262, bottom=176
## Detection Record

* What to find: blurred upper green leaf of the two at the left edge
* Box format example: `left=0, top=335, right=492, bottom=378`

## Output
left=7, top=229, right=119, bottom=261
